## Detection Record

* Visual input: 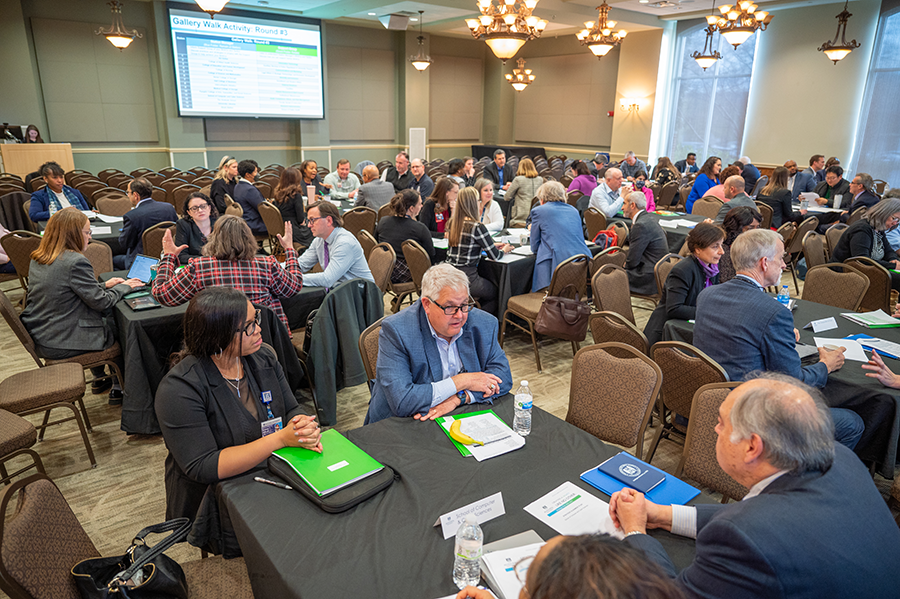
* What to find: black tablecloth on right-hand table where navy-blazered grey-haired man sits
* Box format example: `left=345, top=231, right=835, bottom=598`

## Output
left=663, top=300, right=900, bottom=478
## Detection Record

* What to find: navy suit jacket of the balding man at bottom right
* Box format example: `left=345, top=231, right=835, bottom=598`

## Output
left=625, top=446, right=900, bottom=599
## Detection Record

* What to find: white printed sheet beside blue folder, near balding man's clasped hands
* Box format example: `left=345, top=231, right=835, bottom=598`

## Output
left=525, top=481, right=625, bottom=539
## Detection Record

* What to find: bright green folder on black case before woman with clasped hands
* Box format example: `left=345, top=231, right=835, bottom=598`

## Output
left=272, top=429, right=384, bottom=497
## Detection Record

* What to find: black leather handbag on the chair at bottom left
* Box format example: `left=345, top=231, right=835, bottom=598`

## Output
left=72, top=518, right=191, bottom=599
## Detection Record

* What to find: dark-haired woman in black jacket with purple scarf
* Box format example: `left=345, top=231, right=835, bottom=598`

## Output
left=644, top=222, right=725, bottom=346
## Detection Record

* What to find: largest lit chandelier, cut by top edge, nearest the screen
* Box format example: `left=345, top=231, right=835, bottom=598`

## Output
left=466, top=0, right=547, bottom=64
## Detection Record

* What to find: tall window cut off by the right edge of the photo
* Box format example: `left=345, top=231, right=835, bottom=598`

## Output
left=853, top=9, right=900, bottom=185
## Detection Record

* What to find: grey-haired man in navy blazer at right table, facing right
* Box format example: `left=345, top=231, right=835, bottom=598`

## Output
left=694, top=229, right=864, bottom=449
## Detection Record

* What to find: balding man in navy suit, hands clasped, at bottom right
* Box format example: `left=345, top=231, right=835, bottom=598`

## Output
left=609, top=376, right=900, bottom=599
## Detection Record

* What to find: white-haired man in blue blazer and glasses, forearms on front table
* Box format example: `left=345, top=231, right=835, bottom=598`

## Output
left=365, top=263, right=512, bottom=424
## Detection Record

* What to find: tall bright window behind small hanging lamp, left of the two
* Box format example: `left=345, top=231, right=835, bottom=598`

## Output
left=668, top=23, right=759, bottom=164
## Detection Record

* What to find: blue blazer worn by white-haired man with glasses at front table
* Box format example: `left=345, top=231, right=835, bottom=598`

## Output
left=365, top=300, right=512, bottom=424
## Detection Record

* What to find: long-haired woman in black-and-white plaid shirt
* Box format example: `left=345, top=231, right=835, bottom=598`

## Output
left=447, top=187, right=512, bottom=314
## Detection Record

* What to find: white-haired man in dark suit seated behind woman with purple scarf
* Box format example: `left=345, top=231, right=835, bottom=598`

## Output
left=622, top=191, right=669, bottom=295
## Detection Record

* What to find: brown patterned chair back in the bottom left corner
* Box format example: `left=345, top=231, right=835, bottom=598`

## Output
left=0, top=473, right=100, bottom=599
